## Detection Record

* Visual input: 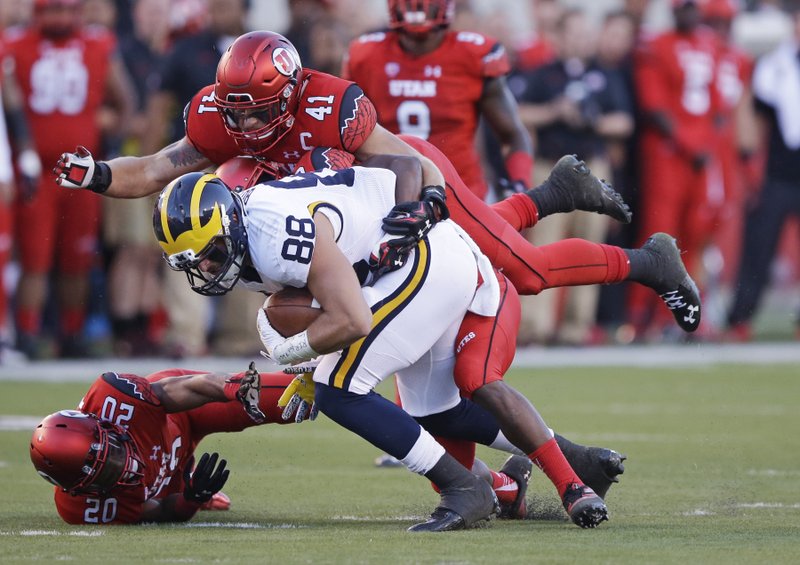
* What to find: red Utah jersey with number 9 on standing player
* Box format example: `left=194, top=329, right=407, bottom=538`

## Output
left=343, top=31, right=510, bottom=194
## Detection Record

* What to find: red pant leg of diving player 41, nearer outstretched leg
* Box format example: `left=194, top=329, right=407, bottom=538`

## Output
left=400, top=135, right=630, bottom=295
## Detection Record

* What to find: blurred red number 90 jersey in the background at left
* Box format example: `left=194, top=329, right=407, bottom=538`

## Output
left=6, top=27, right=116, bottom=163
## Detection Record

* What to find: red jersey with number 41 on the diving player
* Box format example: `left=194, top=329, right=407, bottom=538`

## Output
left=185, top=69, right=376, bottom=170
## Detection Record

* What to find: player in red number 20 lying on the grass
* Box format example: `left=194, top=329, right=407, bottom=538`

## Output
left=30, top=364, right=308, bottom=524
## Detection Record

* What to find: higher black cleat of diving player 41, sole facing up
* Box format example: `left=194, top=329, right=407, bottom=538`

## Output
left=534, top=155, right=633, bottom=224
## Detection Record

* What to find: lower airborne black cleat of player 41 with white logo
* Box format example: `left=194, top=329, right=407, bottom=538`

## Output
left=642, top=232, right=701, bottom=332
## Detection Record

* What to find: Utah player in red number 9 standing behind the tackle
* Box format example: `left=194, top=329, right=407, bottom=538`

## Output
left=342, top=0, right=533, bottom=199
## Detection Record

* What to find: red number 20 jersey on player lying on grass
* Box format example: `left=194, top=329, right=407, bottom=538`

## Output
left=55, top=369, right=195, bottom=524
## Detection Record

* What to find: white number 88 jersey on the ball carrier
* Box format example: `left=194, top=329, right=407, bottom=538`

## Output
left=239, top=167, right=395, bottom=293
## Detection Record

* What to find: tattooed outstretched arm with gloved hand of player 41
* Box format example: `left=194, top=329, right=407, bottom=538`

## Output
left=53, top=137, right=213, bottom=198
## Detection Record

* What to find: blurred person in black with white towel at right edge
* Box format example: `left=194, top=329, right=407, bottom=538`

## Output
left=728, top=1, right=800, bottom=341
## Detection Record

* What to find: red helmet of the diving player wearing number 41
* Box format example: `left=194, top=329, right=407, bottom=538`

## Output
left=214, top=31, right=303, bottom=155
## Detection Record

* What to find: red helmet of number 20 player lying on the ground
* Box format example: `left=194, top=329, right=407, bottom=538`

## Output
left=31, top=410, right=144, bottom=495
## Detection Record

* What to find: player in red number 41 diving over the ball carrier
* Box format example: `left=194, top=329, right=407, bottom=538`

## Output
left=54, top=31, right=700, bottom=331
